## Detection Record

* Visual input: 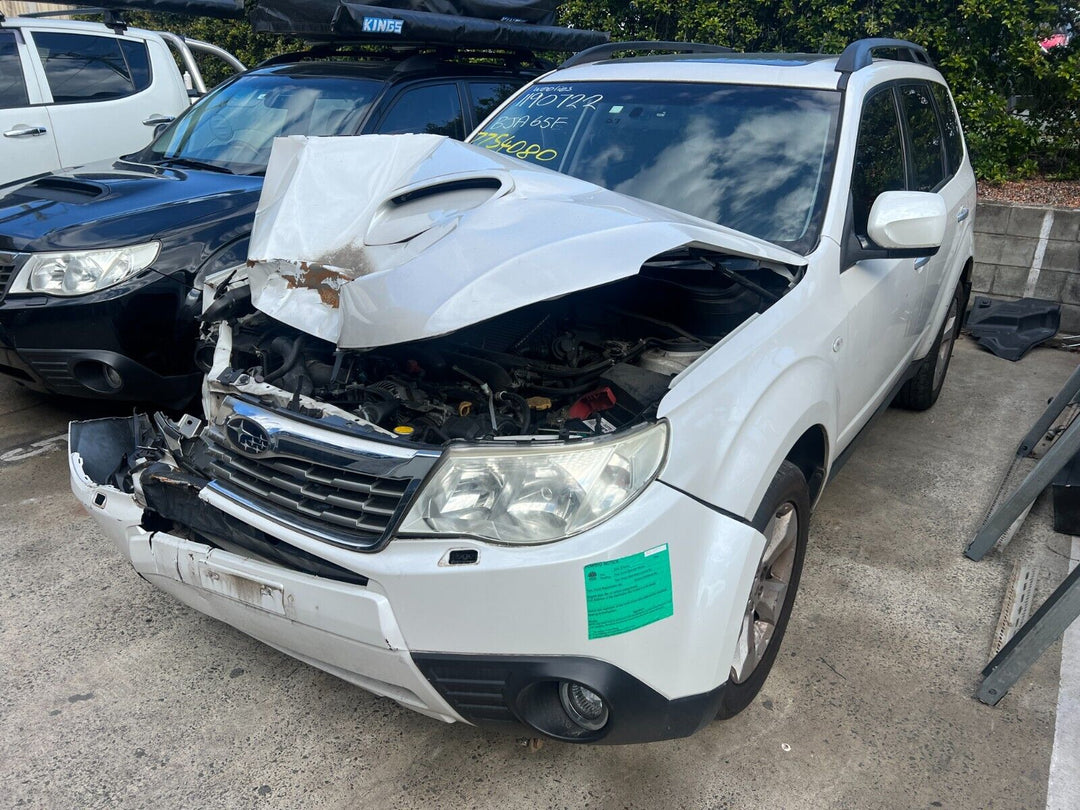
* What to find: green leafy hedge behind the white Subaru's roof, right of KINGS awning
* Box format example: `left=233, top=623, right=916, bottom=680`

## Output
left=561, top=0, right=1080, bottom=180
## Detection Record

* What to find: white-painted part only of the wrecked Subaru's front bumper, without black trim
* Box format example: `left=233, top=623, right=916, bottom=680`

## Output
left=69, top=425, right=765, bottom=704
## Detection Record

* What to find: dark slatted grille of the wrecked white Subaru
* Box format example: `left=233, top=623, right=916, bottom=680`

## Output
left=203, top=431, right=418, bottom=551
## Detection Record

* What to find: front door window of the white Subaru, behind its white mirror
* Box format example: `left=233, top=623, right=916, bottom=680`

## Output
left=851, top=90, right=905, bottom=234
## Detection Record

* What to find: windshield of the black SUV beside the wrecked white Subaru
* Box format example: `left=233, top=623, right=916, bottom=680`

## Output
left=139, top=73, right=382, bottom=174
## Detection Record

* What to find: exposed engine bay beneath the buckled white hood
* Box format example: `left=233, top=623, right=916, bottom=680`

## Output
left=197, top=248, right=799, bottom=446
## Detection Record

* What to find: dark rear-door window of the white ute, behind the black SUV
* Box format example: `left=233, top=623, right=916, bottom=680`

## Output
left=33, top=31, right=135, bottom=104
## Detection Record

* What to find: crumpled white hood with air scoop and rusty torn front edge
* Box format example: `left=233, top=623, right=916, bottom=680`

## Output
left=248, top=135, right=806, bottom=349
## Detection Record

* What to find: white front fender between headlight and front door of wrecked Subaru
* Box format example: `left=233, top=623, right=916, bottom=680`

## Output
left=659, top=268, right=846, bottom=519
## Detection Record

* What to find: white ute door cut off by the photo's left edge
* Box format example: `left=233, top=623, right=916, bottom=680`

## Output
left=0, top=28, right=60, bottom=185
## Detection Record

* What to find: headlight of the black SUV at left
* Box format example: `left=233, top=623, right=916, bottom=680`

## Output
left=10, top=242, right=161, bottom=295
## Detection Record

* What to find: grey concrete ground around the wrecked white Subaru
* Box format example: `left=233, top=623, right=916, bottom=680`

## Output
left=0, top=339, right=1077, bottom=809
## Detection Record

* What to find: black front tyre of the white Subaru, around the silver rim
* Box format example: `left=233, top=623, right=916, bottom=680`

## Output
left=716, top=461, right=810, bottom=720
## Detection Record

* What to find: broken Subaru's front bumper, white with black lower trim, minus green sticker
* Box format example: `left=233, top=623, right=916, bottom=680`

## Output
left=69, top=419, right=764, bottom=743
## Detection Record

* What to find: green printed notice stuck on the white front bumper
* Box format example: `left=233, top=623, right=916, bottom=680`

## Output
left=585, top=543, right=674, bottom=638
